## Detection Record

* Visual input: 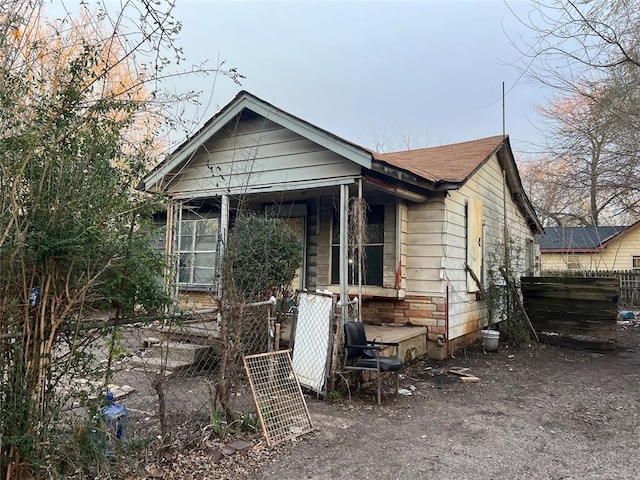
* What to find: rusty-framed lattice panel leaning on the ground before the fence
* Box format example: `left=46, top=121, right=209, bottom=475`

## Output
left=243, top=350, right=313, bottom=446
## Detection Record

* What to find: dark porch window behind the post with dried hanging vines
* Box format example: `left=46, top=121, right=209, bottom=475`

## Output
left=331, top=205, right=384, bottom=287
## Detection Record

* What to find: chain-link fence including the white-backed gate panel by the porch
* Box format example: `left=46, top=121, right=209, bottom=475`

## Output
left=0, top=292, right=339, bottom=472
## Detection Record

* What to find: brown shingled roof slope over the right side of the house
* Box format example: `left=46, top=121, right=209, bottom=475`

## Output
left=373, top=135, right=504, bottom=183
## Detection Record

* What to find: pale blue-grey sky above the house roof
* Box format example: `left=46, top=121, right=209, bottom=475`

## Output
left=165, top=0, right=548, bottom=152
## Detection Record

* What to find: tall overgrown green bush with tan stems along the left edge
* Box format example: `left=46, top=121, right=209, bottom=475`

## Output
left=0, top=2, right=167, bottom=479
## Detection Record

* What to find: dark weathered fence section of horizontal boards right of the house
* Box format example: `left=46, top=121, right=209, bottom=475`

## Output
left=521, top=277, right=620, bottom=350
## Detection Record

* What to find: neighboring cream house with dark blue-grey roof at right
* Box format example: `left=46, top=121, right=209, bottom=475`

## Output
left=536, top=221, right=640, bottom=271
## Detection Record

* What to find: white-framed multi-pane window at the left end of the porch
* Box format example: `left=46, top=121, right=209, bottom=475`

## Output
left=178, top=218, right=218, bottom=285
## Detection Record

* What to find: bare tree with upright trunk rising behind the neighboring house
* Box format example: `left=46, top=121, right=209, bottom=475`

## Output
left=537, top=85, right=637, bottom=225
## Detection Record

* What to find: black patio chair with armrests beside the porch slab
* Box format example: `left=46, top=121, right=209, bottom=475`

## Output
left=343, top=322, right=404, bottom=405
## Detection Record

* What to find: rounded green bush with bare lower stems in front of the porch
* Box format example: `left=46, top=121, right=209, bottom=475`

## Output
left=212, top=213, right=302, bottom=424
